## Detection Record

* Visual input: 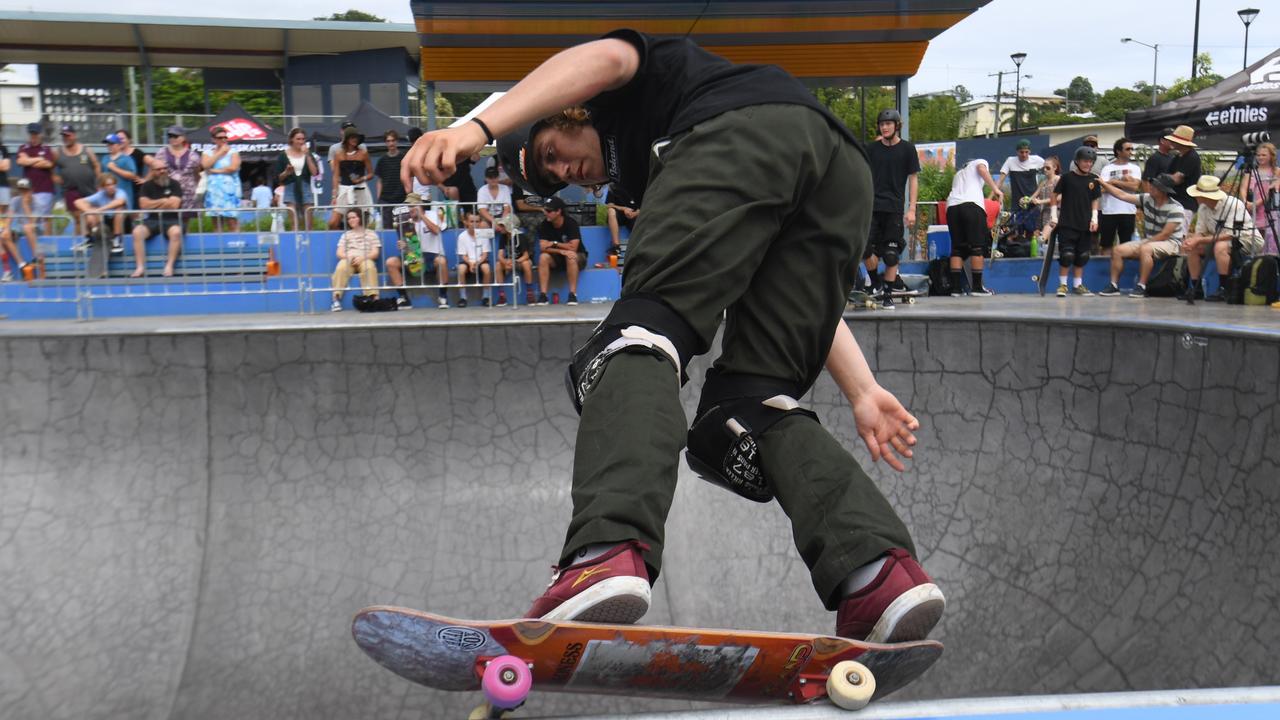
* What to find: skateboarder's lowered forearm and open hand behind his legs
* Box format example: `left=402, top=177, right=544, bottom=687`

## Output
left=827, top=319, right=920, bottom=473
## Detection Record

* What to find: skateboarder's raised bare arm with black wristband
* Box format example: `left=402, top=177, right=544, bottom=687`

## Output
left=401, top=38, right=640, bottom=187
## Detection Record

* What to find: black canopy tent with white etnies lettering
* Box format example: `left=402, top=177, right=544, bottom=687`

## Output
left=1124, top=50, right=1280, bottom=150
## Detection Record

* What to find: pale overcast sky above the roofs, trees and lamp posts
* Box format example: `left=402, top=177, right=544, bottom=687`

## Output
left=0, top=0, right=1280, bottom=96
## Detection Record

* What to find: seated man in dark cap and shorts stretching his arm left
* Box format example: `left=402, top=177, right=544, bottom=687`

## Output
left=1098, top=173, right=1187, bottom=297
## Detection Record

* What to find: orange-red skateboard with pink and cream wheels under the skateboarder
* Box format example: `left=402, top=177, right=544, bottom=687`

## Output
left=352, top=606, right=942, bottom=719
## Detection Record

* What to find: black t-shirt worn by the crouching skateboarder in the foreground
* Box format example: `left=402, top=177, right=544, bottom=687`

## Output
left=586, top=29, right=865, bottom=202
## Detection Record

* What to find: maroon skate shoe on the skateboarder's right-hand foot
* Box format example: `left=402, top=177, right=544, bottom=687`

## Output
left=836, top=547, right=947, bottom=643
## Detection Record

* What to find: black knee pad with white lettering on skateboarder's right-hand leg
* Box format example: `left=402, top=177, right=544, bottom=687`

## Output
left=685, top=375, right=818, bottom=502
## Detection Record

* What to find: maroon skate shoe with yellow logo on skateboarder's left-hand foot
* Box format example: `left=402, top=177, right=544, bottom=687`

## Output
left=525, top=541, right=649, bottom=624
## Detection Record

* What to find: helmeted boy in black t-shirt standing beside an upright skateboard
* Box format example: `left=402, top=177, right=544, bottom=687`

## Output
left=1053, top=145, right=1102, bottom=297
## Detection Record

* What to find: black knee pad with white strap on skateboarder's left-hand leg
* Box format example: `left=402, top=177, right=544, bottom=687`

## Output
left=564, top=295, right=707, bottom=415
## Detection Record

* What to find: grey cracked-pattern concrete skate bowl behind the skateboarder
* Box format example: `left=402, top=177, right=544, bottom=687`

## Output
left=0, top=301, right=1280, bottom=719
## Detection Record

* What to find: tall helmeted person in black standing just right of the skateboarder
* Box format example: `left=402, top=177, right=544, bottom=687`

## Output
left=863, top=110, right=920, bottom=309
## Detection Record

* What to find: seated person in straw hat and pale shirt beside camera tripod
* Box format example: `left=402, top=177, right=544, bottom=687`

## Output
left=1183, top=176, right=1262, bottom=302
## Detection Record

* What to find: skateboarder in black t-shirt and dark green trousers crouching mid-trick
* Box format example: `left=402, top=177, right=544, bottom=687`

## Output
left=404, top=29, right=945, bottom=641
